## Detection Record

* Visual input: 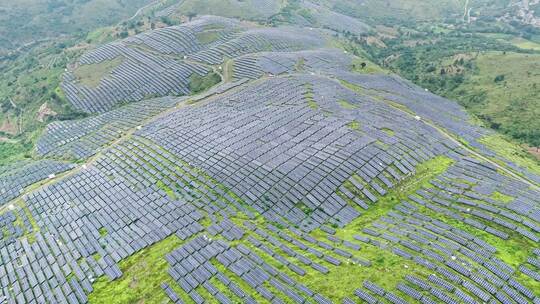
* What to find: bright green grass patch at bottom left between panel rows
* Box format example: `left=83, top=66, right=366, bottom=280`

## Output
left=88, top=235, right=188, bottom=304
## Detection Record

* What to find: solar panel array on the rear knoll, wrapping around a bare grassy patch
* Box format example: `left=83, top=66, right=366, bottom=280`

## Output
left=62, top=16, right=324, bottom=113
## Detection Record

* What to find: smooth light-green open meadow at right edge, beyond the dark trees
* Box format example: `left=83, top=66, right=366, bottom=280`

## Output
left=454, top=52, right=540, bottom=146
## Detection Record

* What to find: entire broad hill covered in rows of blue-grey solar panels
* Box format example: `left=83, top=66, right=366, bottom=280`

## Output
left=0, top=16, right=540, bottom=304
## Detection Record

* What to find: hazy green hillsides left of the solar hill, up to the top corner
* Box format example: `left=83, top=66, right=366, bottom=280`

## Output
left=0, top=0, right=167, bottom=163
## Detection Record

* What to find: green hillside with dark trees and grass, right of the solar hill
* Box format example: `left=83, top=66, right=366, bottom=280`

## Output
left=360, top=18, right=540, bottom=147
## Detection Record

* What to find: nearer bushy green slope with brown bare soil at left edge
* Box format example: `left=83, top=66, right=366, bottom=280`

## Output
left=0, top=38, right=83, bottom=161
